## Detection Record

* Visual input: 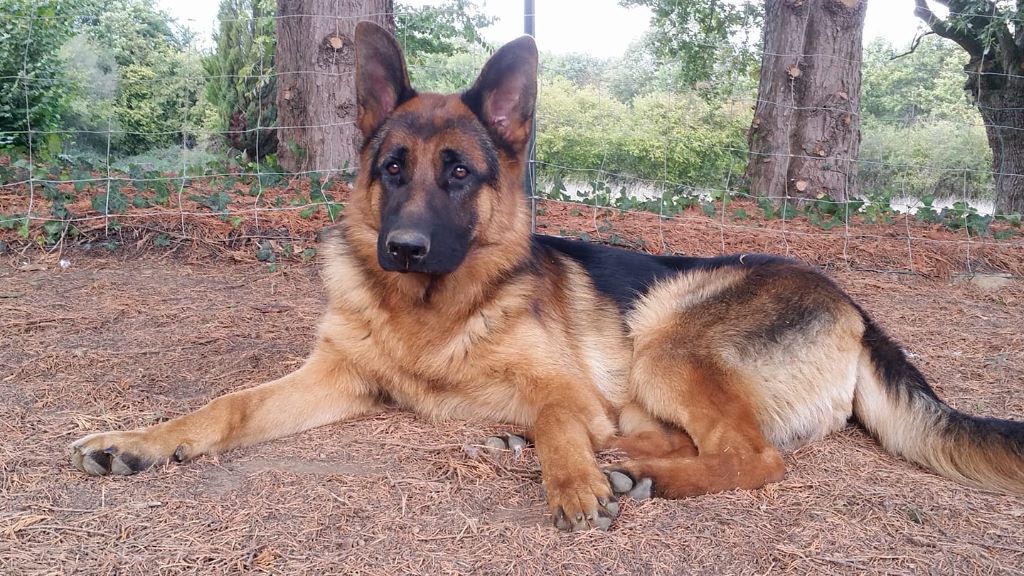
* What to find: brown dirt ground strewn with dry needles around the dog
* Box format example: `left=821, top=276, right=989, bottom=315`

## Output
left=0, top=206, right=1024, bottom=575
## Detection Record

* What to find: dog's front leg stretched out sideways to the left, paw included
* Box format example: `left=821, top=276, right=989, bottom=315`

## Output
left=71, top=346, right=378, bottom=475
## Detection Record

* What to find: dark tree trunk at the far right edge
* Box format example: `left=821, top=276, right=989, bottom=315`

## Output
left=964, top=58, right=1024, bottom=214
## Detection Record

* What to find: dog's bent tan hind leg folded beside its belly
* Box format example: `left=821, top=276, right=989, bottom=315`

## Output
left=612, top=355, right=784, bottom=498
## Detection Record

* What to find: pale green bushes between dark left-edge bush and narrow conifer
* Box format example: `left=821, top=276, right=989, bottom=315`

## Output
left=61, top=0, right=206, bottom=157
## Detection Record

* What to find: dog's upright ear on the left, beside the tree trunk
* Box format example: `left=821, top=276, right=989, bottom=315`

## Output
left=355, top=22, right=416, bottom=139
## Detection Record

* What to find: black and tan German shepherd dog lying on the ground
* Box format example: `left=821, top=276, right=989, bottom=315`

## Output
left=71, top=23, right=1024, bottom=530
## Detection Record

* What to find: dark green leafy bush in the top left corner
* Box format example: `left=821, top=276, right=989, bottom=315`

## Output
left=0, top=0, right=76, bottom=156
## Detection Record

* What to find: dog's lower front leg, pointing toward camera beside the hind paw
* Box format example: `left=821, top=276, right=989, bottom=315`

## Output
left=532, top=404, right=618, bottom=531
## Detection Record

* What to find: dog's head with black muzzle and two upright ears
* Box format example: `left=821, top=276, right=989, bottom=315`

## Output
left=355, top=23, right=537, bottom=276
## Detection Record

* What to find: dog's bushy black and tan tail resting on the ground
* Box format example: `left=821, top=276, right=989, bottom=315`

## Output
left=853, top=311, right=1024, bottom=495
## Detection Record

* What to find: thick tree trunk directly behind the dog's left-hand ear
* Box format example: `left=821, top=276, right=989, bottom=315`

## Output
left=274, top=0, right=394, bottom=173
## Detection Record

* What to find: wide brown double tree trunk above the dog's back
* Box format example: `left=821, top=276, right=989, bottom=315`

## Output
left=746, top=0, right=867, bottom=201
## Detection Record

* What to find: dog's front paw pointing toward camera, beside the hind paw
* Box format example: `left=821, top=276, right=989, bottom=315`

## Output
left=545, top=468, right=618, bottom=532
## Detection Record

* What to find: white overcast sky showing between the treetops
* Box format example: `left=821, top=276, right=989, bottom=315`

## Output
left=157, top=0, right=933, bottom=57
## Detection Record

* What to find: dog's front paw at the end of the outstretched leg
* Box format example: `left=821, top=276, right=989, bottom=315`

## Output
left=71, top=430, right=186, bottom=476
